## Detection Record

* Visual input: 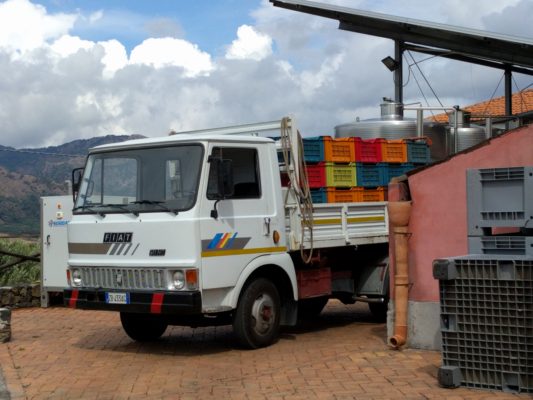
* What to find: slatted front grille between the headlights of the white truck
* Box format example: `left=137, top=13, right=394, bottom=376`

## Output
left=79, top=267, right=166, bottom=289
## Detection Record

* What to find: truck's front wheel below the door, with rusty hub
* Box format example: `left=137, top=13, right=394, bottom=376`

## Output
left=233, top=278, right=281, bottom=349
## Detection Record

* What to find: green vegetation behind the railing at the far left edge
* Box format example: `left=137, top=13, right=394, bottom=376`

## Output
left=0, top=239, right=41, bottom=286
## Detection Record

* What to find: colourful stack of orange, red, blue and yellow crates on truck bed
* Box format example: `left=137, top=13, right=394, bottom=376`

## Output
left=282, top=136, right=430, bottom=203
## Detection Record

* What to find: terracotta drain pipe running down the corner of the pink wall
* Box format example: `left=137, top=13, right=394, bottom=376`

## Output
left=387, top=201, right=411, bottom=349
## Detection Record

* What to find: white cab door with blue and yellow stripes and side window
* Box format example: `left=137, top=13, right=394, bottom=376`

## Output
left=200, top=144, right=280, bottom=290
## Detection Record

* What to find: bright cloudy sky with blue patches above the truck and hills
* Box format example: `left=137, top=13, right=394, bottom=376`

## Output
left=0, top=0, right=533, bottom=148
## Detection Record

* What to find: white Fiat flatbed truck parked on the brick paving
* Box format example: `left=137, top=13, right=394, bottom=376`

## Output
left=64, top=118, right=388, bottom=348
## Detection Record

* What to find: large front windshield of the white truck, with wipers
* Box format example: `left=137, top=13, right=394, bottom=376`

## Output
left=74, top=144, right=203, bottom=214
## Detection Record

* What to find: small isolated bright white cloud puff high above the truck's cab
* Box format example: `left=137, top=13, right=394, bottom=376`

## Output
left=226, top=25, right=272, bottom=61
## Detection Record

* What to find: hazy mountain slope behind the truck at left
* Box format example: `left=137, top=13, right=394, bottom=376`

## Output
left=0, top=135, right=142, bottom=235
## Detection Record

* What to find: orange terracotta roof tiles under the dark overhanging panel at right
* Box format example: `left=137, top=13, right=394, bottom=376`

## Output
left=428, top=89, right=533, bottom=123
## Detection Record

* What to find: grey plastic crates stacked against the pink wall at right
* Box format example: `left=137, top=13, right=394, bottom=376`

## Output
left=433, top=167, right=533, bottom=393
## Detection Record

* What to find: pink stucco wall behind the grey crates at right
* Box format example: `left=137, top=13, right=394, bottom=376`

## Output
left=389, top=126, right=533, bottom=302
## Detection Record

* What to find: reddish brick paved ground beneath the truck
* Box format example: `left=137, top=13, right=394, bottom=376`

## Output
left=0, top=302, right=531, bottom=400
